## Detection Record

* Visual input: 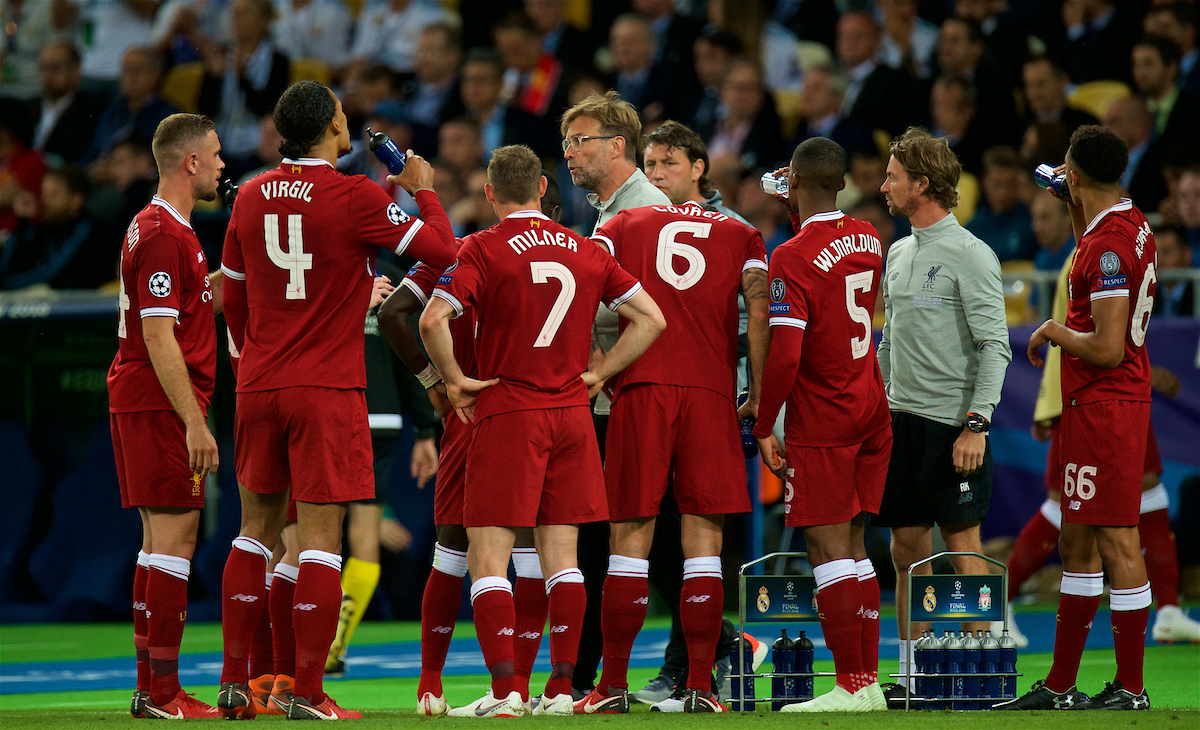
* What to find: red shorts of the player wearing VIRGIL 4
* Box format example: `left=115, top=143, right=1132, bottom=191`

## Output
left=233, top=387, right=374, bottom=504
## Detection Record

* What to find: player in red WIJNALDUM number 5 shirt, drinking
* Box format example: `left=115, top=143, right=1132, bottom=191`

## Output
left=754, top=137, right=892, bottom=712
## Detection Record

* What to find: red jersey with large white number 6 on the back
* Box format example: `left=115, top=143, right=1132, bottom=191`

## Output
left=595, top=202, right=767, bottom=401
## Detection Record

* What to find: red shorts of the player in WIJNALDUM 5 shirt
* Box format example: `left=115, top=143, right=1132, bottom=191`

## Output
left=784, top=424, right=892, bottom=527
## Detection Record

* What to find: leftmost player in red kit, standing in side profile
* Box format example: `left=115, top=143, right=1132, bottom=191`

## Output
left=108, top=114, right=228, bottom=719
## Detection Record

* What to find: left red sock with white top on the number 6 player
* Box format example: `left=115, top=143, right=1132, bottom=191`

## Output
left=596, top=555, right=650, bottom=693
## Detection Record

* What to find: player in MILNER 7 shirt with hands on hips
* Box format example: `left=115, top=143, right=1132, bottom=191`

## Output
left=421, top=145, right=665, bottom=717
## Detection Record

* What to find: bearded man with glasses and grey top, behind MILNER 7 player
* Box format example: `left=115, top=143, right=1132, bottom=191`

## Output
left=560, top=91, right=671, bottom=699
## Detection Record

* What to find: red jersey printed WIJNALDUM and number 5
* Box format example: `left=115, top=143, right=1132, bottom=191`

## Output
left=755, top=210, right=890, bottom=447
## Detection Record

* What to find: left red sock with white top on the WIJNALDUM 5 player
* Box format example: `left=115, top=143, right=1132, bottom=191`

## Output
left=812, top=558, right=870, bottom=694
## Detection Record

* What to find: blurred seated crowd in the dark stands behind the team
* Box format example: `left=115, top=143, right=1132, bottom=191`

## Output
left=0, top=0, right=1200, bottom=322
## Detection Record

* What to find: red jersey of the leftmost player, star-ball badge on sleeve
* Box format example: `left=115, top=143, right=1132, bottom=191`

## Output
left=108, top=196, right=217, bottom=413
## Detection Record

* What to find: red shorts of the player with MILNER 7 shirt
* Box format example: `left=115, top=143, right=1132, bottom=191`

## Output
left=462, top=406, right=608, bottom=527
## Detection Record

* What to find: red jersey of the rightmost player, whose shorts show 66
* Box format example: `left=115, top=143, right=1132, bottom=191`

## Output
left=1062, top=198, right=1158, bottom=405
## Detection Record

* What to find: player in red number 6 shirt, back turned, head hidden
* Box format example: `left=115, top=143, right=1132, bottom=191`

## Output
left=576, top=188, right=767, bottom=713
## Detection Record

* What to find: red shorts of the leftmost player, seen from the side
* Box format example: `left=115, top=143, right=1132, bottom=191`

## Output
left=108, top=411, right=204, bottom=509
